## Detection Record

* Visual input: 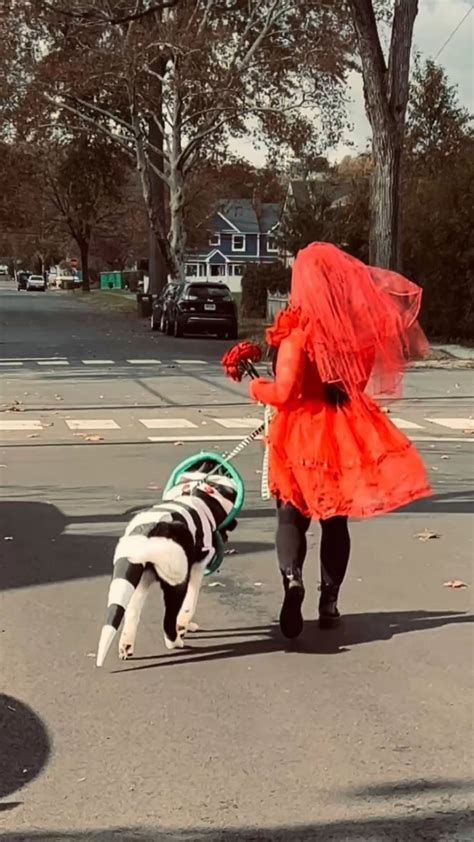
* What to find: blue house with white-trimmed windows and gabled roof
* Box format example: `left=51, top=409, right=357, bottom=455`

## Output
left=185, top=199, right=281, bottom=292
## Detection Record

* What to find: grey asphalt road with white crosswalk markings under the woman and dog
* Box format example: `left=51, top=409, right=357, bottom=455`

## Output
left=0, top=285, right=474, bottom=842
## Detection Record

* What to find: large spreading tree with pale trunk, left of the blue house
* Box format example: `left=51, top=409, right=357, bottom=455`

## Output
left=3, top=0, right=352, bottom=286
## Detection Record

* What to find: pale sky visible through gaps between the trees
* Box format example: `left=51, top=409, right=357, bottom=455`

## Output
left=233, top=0, right=474, bottom=166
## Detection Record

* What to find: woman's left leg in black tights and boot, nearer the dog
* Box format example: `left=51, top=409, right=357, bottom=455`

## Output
left=276, top=501, right=310, bottom=638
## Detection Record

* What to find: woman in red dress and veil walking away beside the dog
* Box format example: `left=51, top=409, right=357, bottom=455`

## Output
left=250, top=243, right=431, bottom=638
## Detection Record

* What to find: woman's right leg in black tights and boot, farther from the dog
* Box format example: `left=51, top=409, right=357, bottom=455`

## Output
left=319, top=517, right=351, bottom=628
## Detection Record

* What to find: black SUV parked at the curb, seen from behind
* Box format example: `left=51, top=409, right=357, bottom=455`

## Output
left=166, top=281, right=238, bottom=339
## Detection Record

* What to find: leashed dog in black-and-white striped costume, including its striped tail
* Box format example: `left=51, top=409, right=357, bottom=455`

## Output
left=96, top=462, right=237, bottom=667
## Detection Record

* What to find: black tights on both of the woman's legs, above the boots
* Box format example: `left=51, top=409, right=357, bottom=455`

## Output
left=276, top=501, right=351, bottom=587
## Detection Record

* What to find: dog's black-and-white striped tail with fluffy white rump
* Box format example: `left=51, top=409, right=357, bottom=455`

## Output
left=96, top=535, right=188, bottom=667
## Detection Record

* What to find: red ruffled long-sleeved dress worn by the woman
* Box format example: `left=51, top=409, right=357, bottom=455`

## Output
left=250, top=309, right=431, bottom=520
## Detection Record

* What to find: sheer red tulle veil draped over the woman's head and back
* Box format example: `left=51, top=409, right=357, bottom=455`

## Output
left=291, top=243, right=428, bottom=397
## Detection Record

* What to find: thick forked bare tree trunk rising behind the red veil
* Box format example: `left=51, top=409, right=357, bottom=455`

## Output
left=348, top=0, right=418, bottom=269
